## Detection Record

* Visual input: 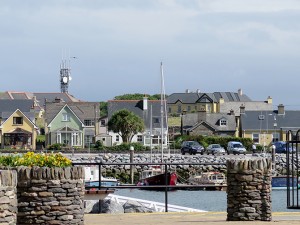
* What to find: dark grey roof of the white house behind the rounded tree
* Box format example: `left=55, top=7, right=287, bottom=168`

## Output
left=108, top=100, right=166, bottom=129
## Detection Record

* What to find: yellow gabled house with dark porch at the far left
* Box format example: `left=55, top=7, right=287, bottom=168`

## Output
left=0, top=109, right=38, bottom=150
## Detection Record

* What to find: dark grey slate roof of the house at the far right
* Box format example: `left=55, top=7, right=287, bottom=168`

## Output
left=241, top=110, right=300, bottom=130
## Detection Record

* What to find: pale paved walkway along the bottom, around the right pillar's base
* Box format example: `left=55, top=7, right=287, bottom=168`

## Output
left=84, top=210, right=300, bottom=225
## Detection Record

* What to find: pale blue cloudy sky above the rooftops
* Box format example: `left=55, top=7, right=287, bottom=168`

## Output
left=0, top=0, right=300, bottom=110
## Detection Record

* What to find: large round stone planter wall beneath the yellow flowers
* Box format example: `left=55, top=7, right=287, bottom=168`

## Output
left=17, top=167, right=84, bottom=225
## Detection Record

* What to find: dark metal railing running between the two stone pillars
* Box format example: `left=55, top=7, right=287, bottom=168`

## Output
left=73, top=162, right=226, bottom=212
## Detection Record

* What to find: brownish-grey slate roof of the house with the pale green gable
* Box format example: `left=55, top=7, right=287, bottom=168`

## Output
left=45, top=102, right=100, bottom=124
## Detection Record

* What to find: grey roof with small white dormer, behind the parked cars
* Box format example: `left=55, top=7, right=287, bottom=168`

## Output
left=183, top=113, right=236, bottom=131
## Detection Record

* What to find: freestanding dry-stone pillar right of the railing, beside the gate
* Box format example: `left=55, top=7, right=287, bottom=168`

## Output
left=227, top=158, right=272, bottom=221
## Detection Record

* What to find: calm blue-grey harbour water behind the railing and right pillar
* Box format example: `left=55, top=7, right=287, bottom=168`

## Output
left=114, top=189, right=300, bottom=212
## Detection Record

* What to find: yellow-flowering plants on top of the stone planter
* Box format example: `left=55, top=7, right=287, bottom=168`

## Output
left=0, top=152, right=72, bottom=167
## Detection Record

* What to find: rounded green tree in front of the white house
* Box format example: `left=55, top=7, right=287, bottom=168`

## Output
left=108, top=109, right=145, bottom=143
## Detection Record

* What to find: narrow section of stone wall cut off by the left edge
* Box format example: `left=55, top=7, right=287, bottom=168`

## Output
left=0, top=170, right=18, bottom=225
